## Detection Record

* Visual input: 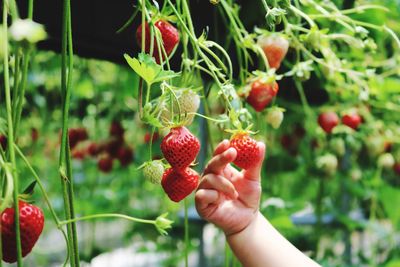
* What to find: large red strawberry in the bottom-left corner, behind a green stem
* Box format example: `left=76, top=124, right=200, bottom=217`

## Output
left=1, top=200, right=44, bottom=263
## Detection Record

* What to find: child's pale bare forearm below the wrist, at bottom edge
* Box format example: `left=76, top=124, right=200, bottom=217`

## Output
left=227, top=213, right=320, bottom=267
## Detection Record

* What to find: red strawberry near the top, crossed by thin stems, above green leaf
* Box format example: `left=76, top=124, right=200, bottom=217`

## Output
left=136, top=20, right=179, bottom=63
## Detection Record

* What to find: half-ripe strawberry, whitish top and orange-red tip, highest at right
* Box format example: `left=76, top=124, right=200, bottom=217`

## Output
left=258, top=34, right=289, bottom=69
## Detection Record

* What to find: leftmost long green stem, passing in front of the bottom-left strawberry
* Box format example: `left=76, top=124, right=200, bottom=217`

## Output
left=3, top=0, right=22, bottom=267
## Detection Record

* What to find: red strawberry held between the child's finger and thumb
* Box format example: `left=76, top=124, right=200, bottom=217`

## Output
left=230, top=132, right=259, bottom=170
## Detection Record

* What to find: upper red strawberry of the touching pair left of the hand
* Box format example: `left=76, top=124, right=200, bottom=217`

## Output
left=161, top=127, right=200, bottom=170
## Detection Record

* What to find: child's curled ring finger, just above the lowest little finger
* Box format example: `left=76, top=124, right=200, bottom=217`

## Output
left=199, top=174, right=238, bottom=198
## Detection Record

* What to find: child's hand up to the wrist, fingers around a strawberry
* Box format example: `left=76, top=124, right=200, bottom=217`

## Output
left=196, top=140, right=265, bottom=235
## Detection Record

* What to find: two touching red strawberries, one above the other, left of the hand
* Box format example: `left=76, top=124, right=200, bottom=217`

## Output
left=161, top=126, right=200, bottom=202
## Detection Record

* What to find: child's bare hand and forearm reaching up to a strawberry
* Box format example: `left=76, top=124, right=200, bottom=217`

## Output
left=195, top=140, right=320, bottom=267
